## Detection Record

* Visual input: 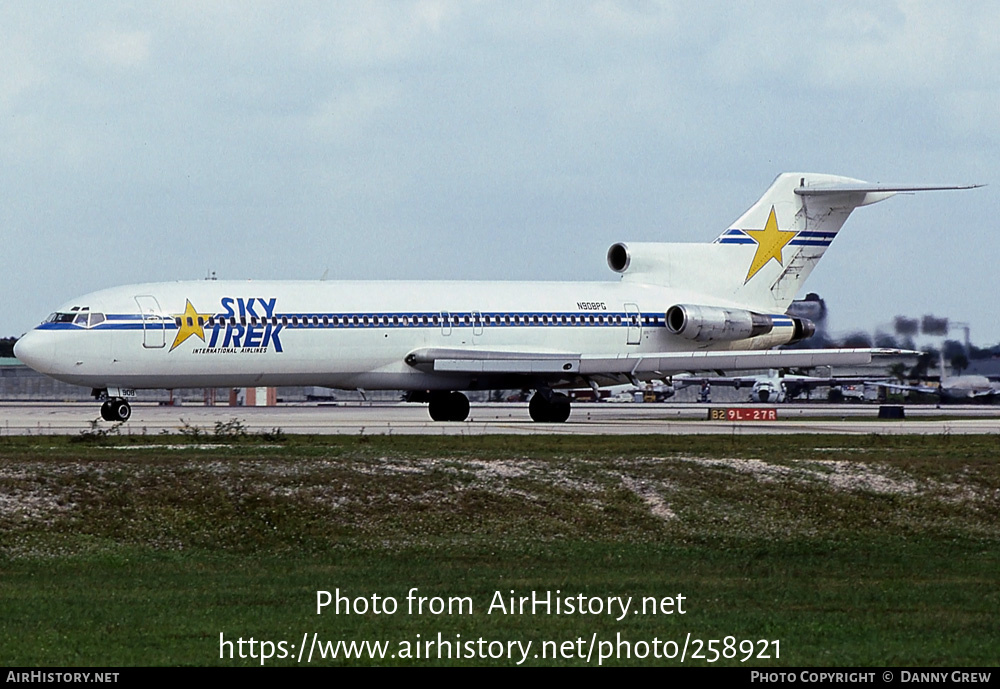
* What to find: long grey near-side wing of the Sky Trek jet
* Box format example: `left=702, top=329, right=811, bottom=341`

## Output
left=405, top=348, right=910, bottom=378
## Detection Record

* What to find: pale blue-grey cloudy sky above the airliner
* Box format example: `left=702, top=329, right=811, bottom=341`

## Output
left=0, top=0, right=1000, bottom=345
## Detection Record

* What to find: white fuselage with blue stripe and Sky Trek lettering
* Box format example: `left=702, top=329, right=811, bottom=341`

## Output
left=17, top=281, right=791, bottom=390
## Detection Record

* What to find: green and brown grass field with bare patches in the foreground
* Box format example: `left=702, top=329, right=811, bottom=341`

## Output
left=0, top=432, right=1000, bottom=666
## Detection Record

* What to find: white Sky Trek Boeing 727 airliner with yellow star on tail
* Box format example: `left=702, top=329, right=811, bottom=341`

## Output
left=15, top=173, right=971, bottom=422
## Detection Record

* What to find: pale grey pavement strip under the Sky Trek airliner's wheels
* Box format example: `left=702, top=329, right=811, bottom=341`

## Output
left=0, top=403, right=1000, bottom=435
